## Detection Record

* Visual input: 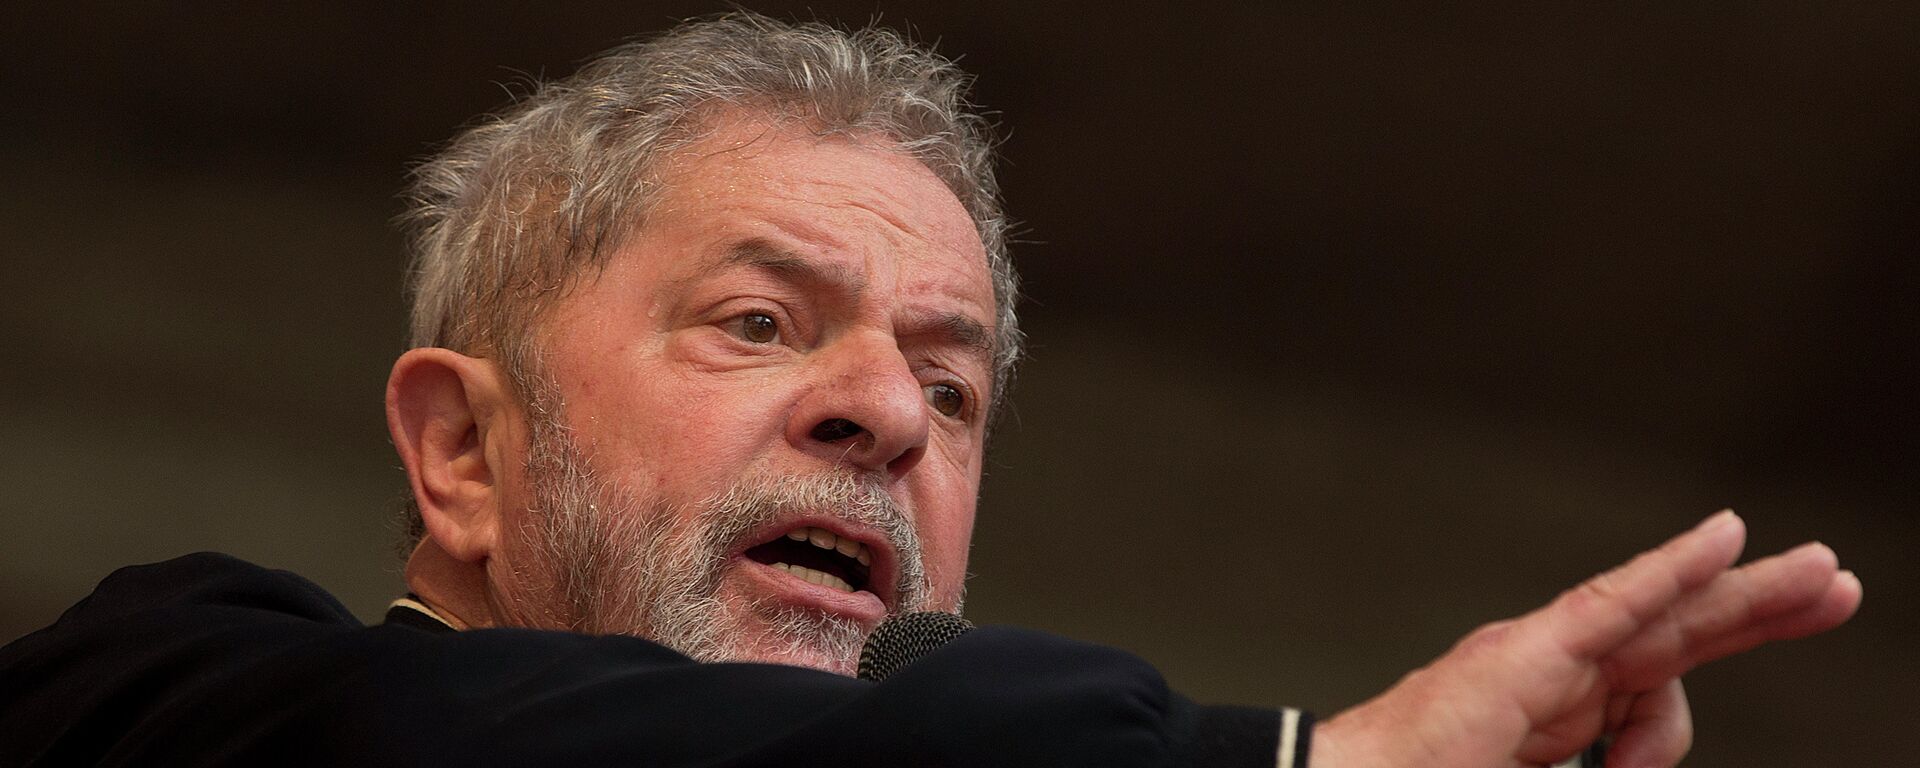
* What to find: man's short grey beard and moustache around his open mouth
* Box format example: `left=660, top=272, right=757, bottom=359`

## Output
left=516, top=407, right=933, bottom=670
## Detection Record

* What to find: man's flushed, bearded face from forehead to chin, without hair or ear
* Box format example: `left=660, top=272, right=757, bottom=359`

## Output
left=472, top=114, right=996, bottom=674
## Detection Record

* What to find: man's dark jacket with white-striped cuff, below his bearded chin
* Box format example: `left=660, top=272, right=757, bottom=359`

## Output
left=0, top=555, right=1304, bottom=766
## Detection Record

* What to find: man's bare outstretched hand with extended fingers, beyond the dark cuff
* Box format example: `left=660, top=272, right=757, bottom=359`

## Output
left=1309, top=511, right=1860, bottom=768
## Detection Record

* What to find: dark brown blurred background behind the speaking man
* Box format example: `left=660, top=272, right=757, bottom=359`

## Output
left=0, top=2, right=1920, bottom=768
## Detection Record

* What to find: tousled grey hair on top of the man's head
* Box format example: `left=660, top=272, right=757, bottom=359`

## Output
left=395, top=13, right=1021, bottom=395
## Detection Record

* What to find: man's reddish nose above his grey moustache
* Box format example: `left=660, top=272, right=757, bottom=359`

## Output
left=787, top=338, right=931, bottom=478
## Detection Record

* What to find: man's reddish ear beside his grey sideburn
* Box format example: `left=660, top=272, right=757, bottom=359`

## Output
left=386, top=348, right=524, bottom=563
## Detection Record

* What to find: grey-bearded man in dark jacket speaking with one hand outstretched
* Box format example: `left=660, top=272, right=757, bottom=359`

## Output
left=0, top=15, right=1860, bottom=768
